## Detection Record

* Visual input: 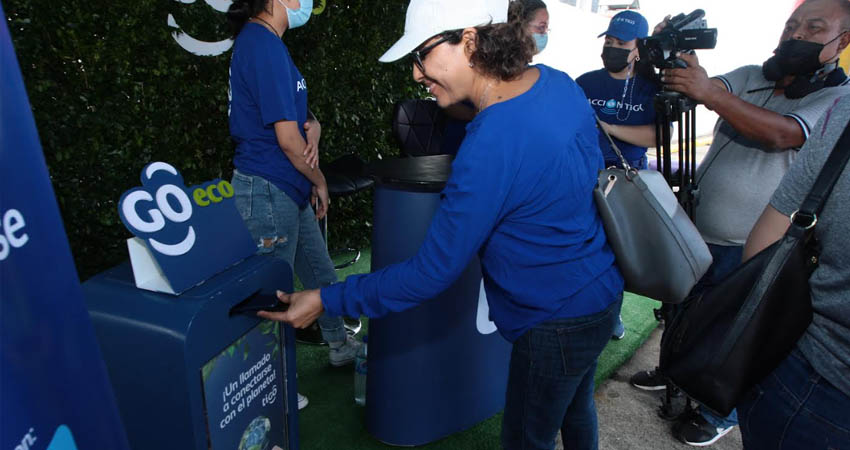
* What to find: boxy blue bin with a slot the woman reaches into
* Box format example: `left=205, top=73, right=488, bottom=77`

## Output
left=83, top=256, right=299, bottom=450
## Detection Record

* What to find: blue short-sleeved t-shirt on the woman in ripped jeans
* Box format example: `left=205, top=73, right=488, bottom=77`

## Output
left=228, top=23, right=312, bottom=207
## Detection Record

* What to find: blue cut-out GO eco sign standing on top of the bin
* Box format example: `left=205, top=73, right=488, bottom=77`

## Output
left=118, top=162, right=257, bottom=293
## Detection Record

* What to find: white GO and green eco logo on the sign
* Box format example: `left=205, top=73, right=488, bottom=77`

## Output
left=118, top=162, right=233, bottom=256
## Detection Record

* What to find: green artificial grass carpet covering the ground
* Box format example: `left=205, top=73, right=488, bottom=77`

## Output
left=296, top=249, right=659, bottom=450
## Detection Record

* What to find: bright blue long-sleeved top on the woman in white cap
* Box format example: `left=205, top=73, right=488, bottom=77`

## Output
left=322, top=65, right=623, bottom=341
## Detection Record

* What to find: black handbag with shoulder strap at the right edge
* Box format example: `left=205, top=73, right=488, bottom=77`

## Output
left=659, top=122, right=850, bottom=416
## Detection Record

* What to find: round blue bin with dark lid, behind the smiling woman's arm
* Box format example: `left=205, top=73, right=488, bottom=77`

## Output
left=366, top=155, right=511, bottom=446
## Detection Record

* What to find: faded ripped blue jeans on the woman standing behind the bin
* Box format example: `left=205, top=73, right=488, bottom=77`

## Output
left=231, top=171, right=346, bottom=342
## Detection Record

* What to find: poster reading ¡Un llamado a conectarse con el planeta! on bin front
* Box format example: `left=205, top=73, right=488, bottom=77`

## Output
left=201, top=321, right=288, bottom=450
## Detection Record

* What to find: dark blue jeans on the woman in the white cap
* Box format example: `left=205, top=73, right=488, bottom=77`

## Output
left=502, top=297, right=623, bottom=450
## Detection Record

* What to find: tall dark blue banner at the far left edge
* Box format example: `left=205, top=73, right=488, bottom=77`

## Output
left=0, top=5, right=129, bottom=450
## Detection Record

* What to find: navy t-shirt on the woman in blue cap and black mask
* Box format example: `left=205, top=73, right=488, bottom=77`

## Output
left=576, top=69, right=658, bottom=165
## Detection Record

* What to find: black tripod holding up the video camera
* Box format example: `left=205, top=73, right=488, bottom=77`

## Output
left=654, top=91, right=699, bottom=420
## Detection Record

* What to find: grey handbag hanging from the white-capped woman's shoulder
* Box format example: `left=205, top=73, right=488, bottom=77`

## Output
left=593, top=119, right=711, bottom=303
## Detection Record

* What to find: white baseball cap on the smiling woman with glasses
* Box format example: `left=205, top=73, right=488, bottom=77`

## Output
left=378, top=0, right=509, bottom=62
